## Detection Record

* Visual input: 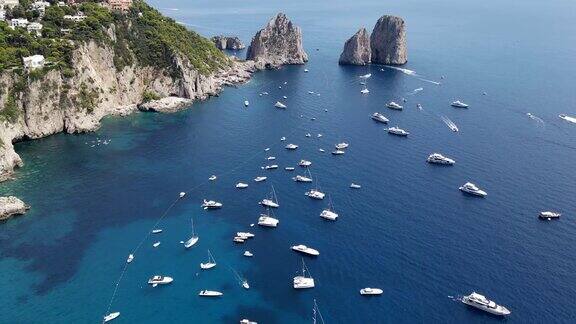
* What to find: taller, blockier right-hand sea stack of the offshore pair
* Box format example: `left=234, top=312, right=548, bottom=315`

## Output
left=370, top=15, right=408, bottom=65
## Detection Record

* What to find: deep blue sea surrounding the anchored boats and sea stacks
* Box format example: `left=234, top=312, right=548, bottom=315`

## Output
left=0, top=0, right=576, bottom=323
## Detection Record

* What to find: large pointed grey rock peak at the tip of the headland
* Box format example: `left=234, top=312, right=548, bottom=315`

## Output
left=246, top=13, right=308, bottom=69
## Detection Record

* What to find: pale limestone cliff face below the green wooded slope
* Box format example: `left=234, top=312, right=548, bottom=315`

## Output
left=0, top=43, right=254, bottom=181
